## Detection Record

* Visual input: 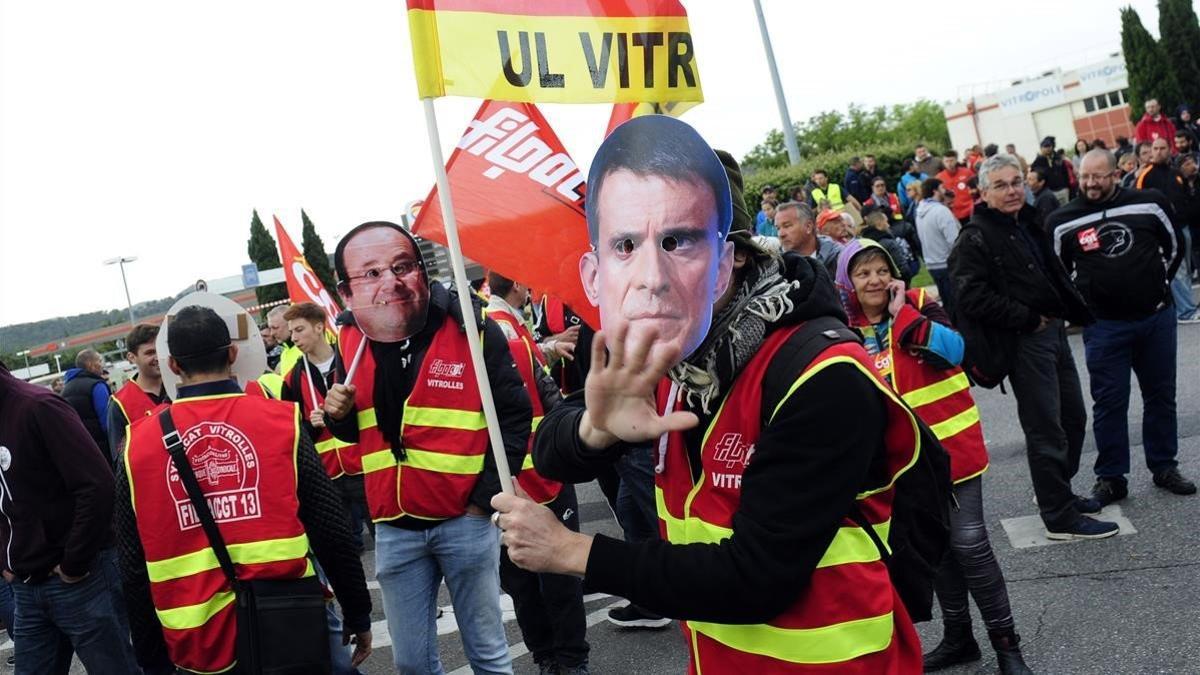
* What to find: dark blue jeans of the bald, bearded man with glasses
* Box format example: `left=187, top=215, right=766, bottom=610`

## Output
left=1084, top=307, right=1178, bottom=479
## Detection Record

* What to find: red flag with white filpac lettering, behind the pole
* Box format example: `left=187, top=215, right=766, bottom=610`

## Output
left=413, top=101, right=600, bottom=327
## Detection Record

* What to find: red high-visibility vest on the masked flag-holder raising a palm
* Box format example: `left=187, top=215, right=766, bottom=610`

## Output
left=655, top=327, right=922, bottom=675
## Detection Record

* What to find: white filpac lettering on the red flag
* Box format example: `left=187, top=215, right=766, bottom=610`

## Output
left=458, top=108, right=584, bottom=203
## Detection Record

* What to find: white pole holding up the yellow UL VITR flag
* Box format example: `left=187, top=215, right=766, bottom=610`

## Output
left=421, top=97, right=512, bottom=495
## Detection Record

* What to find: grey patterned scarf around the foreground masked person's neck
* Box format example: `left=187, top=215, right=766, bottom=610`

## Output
left=668, top=258, right=799, bottom=414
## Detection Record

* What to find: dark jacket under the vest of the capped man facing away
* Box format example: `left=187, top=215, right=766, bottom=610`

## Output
left=114, top=380, right=371, bottom=673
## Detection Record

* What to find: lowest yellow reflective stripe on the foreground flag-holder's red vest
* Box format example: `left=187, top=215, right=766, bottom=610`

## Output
left=688, top=611, right=895, bottom=664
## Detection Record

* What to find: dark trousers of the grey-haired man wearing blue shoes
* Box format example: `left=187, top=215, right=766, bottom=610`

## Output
left=1008, top=319, right=1087, bottom=530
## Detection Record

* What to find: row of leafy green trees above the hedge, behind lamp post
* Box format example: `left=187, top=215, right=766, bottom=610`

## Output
left=742, top=100, right=950, bottom=173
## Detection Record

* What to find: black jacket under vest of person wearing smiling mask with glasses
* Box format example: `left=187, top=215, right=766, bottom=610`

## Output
left=325, top=281, right=533, bottom=530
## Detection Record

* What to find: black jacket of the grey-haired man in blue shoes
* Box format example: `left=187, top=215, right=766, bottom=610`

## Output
left=948, top=204, right=1092, bottom=334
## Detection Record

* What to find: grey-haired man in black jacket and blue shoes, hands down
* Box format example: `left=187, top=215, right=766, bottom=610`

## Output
left=949, top=155, right=1117, bottom=539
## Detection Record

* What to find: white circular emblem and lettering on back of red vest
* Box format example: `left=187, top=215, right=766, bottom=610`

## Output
left=167, top=422, right=262, bottom=530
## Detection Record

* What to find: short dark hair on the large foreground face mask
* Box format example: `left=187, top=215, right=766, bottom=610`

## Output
left=584, top=115, right=733, bottom=246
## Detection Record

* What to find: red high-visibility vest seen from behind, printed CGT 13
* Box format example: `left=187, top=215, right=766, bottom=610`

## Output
left=125, top=394, right=313, bottom=673
